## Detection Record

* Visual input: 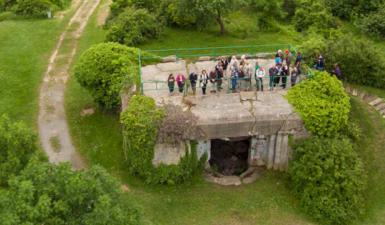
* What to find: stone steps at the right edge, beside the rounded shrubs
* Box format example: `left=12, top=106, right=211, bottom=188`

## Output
left=345, top=86, right=385, bottom=118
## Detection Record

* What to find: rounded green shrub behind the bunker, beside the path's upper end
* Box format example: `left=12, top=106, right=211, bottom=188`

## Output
left=106, top=8, right=163, bottom=46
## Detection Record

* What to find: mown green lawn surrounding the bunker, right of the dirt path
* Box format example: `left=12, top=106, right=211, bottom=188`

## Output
left=66, top=4, right=385, bottom=225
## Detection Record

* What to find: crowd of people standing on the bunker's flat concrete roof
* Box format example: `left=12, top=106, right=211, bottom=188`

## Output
left=167, top=50, right=302, bottom=95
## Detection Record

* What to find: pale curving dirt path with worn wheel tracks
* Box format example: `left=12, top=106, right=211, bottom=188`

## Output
left=38, top=0, right=100, bottom=169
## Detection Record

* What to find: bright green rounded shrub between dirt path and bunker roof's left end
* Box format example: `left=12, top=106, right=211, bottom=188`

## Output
left=74, top=43, right=138, bottom=109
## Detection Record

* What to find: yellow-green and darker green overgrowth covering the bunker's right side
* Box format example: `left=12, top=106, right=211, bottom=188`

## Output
left=287, top=72, right=366, bottom=224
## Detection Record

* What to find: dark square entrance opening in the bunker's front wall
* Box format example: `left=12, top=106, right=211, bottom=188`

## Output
left=209, top=138, right=250, bottom=176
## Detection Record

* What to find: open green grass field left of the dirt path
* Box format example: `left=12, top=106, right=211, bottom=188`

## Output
left=0, top=7, right=77, bottom=128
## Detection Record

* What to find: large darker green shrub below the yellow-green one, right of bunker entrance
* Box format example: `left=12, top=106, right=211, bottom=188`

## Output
left=289, top=137, right=366, bottom=225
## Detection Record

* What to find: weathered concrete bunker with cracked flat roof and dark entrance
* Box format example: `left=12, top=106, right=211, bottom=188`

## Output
left=123, top=53, right=307, bottom=185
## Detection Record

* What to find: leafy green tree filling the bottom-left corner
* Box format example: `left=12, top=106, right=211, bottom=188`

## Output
left=0, top=163, right=142, bottom=225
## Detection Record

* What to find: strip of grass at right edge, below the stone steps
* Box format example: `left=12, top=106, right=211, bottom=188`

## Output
left=352, top=97, right=385, bottom=225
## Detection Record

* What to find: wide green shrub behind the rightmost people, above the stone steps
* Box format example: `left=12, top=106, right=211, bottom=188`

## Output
left=299, top=35, right=385, bottom=88
